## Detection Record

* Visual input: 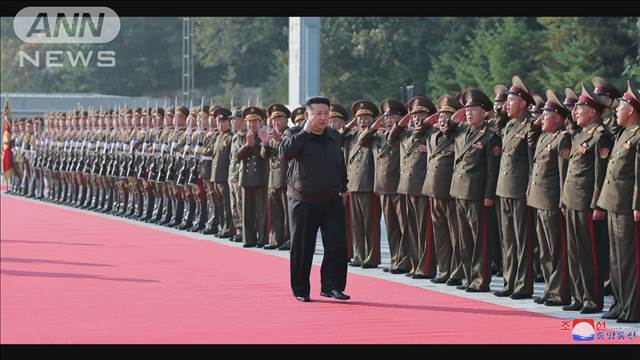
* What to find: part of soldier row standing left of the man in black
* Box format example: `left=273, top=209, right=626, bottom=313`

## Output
left=9, top=104, right=302, bottom=250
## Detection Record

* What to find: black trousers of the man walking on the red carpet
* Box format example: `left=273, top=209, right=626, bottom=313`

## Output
left=289, top=196, right=348, bottom=296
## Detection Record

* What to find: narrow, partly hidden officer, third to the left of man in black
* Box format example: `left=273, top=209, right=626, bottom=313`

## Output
left=229, top=109, right=247, bottom=242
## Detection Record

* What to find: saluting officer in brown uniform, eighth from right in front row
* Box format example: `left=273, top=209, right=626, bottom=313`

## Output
left=363, top=99, right=411, bottom=274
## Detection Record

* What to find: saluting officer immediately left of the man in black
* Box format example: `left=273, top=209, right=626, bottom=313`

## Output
left=260, top=104, right=291, bottom=250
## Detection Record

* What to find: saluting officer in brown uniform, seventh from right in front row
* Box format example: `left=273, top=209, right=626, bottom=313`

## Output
left=389, top=96, right=436, bottom=279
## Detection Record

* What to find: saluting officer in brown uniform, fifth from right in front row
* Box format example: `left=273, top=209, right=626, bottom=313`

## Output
left=450, top=88, right=501, bottom=292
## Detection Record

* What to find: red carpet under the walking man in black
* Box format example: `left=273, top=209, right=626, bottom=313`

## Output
left=0, top=196, right=571, bottom=344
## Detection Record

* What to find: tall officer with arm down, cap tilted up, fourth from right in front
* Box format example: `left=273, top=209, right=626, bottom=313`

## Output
left=495, top=75, right=539, bottom=299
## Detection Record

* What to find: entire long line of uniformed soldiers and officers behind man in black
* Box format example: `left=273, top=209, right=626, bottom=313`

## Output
left=6, top=76, right=640, bottom=322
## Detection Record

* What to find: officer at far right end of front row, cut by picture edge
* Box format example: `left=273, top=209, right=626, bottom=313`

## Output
left=597, top=81, right=640, bottom=323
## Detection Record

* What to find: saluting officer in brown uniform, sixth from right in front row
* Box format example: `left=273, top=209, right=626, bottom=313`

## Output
left=422, top=95, right=464, bottom=286
